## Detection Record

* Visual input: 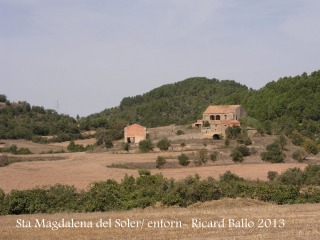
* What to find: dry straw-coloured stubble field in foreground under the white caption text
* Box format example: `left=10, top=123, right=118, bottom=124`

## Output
left=0, top=199, right=320, bottom=240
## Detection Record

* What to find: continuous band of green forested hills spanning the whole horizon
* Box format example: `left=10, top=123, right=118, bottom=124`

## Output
left=0, top=70, right=320, bottom=140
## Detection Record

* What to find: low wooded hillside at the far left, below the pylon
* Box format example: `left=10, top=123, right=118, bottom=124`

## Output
left=0, top=95, right=81, bottom=141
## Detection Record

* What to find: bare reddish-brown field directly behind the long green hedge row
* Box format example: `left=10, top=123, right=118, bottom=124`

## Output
left=0, top=152, right=307, bottom=192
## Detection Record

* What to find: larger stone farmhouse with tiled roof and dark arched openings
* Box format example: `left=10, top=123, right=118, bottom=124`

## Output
left=193, top=105, right=246, bottom=139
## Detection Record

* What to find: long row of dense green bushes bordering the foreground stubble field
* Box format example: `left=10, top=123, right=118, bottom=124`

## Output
left=0, top=165, right=320, bottom=215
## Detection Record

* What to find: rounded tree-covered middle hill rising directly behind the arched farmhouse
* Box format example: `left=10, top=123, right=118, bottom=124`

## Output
left=80, top=77, right=248, bottom=128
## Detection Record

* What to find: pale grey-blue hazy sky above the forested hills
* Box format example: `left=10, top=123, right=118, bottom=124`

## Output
left=0, top=0, right=320, bottom=116
